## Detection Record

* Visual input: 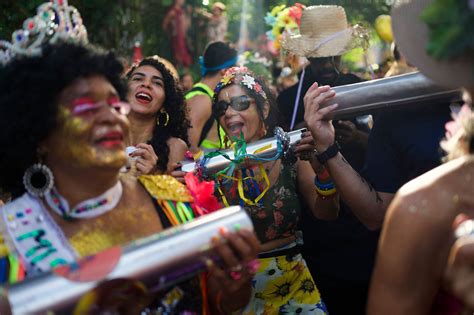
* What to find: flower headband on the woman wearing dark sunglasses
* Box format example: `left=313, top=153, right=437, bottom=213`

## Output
left=214, top=67, right=268, bottom=101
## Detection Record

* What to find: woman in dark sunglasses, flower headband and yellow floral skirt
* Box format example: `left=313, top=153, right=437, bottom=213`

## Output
left=213, top=67, right=339, bottom=314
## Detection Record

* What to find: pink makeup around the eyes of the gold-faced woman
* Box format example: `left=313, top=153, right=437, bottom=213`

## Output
left=71, top=97, right=130, bottom=116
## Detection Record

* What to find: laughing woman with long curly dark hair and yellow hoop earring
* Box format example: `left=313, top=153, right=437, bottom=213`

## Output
left=127, top=57, right=190, bottom=174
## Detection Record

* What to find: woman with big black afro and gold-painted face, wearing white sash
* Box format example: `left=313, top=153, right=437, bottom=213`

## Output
left=0, top=42, right=259, bottom=314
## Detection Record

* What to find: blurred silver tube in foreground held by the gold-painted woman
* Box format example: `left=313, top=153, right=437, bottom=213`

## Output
left=0, top=206, right=253, bottom=315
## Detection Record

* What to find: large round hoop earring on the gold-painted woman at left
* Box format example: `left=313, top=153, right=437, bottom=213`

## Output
left=23, top=163, right=54, bottom=197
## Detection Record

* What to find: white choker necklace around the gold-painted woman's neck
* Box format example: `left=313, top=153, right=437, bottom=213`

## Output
left=45, top=181, right=123, bottom=220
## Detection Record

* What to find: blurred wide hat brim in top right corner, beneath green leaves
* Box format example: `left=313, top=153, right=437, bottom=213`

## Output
left=392, top=0, right=474, bottom=87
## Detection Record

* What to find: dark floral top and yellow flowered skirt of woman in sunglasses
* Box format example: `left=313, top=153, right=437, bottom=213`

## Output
left=221, top=163, right=327, bottom=315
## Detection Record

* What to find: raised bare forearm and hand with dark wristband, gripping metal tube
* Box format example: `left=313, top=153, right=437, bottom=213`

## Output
left=304, top=83, right=393, bottom=230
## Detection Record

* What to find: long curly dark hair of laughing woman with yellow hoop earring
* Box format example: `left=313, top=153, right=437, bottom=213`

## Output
left=126, top=57, right=191, bottom=172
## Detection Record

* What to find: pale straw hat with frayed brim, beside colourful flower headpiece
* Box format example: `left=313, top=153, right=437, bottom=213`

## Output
left=282, top=5, right=353, bottom=57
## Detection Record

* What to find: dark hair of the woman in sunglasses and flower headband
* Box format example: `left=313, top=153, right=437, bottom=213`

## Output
left=212, top=68, right=279, bottom=148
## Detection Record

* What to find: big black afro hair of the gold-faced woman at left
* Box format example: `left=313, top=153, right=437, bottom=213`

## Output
left=0, top=42, right=126, bottom=196
